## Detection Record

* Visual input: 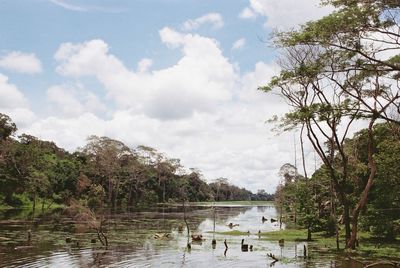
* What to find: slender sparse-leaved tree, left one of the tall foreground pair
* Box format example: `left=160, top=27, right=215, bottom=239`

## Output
left=261, top=46, right=359, bottom=245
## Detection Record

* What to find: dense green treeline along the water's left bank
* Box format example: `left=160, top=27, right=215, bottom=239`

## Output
left=0, top=114, right=272, bottom=208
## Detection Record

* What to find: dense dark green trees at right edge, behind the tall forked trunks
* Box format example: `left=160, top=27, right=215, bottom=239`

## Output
left=348, top=123, right=400, bottom=240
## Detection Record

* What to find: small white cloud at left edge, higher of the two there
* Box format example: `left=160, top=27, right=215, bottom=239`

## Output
left=0, top=51, right=42, bottom=74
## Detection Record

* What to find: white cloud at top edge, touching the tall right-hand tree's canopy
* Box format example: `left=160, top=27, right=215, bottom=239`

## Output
left=239, top=0, right=332, bottom=29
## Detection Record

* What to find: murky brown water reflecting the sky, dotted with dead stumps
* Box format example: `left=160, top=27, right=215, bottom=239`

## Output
left=0, top=204, right=357, bottom=268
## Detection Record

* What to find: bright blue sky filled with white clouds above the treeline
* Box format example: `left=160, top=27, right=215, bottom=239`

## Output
left=0, top=0, right=331, bottom=193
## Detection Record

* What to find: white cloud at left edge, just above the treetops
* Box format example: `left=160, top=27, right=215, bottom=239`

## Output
left=0, top=73, right=35, bottom=127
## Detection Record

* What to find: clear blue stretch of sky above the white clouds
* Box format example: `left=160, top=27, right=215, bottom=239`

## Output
left=0, top=0, right=274, bottom=108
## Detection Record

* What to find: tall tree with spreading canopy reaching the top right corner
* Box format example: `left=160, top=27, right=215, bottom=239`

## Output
left=264, top=0, right=400, bottom=248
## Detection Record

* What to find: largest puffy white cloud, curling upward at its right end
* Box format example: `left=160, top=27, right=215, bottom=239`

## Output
left=55, top=27, right=237, bottom=120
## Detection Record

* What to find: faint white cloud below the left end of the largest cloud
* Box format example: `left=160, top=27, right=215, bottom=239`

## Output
left=47, top=84, right=106, bottom=117
